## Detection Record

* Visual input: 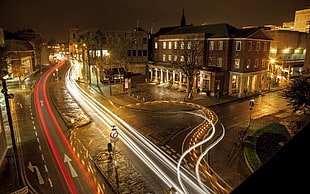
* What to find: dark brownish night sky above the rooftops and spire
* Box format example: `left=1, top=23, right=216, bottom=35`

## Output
left=0, top=0, right=310, bottom=41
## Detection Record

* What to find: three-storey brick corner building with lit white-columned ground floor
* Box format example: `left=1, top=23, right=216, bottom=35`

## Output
left=149, top=24, right=271, bottom=97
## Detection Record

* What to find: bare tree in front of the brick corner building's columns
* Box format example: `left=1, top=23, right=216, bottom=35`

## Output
left=174, top=40, right=204, bottom=99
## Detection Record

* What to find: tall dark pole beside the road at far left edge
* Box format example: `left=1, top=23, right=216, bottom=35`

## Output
left=1, top=78, right=21, bottom=187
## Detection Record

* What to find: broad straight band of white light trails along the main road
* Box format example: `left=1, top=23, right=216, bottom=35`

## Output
left=66, top=60, right=211, bottom=193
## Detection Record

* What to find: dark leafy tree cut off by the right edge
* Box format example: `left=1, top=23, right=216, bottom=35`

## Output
left=283, top=75, right=310, bottom=115
